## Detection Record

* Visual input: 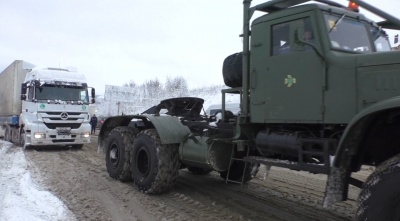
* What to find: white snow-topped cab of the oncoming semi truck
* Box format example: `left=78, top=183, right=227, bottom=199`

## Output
left=20, top=68, right=95, bottom=148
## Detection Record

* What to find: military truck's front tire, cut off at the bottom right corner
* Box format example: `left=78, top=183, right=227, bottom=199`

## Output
left=356, top=155, right=400, bottom=221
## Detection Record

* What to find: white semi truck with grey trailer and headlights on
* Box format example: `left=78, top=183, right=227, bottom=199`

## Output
left=0, top=60, right=95, bottom=148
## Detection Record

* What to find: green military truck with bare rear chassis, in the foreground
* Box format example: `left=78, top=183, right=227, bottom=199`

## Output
left=99, top=0, right=400, bottom=220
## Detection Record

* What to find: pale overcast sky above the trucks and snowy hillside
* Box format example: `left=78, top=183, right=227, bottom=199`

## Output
left=0, top=0, right=400, bottom=94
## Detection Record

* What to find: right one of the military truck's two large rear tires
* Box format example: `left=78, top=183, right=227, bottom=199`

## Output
left=131, top=129, right=180, bottom=194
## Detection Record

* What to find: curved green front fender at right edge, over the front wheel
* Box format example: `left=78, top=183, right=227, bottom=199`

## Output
left=323, top=97, right=400, bottom=207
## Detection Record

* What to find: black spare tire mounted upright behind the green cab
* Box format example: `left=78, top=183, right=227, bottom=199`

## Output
left=222, top=52, right=243, bottom=87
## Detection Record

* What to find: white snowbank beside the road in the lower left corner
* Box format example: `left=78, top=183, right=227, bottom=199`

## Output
left=0, top=140, right=76, bottom=221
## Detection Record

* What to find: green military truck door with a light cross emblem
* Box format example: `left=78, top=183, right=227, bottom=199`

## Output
left=250, top=13, right=324, bottom=123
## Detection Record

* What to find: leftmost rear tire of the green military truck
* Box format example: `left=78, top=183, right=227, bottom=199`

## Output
left=105, top=127, right=136, bottom=181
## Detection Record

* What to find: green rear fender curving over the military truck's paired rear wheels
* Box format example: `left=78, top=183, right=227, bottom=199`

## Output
left=98, top=115, right=190, bottom=152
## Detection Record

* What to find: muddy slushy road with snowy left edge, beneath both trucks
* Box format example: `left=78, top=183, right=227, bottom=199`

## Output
left=0, top=135, right=372, bottom=221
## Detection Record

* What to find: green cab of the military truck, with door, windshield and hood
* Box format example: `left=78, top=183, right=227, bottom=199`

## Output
left=248, top=1, right=398, bottom=124
